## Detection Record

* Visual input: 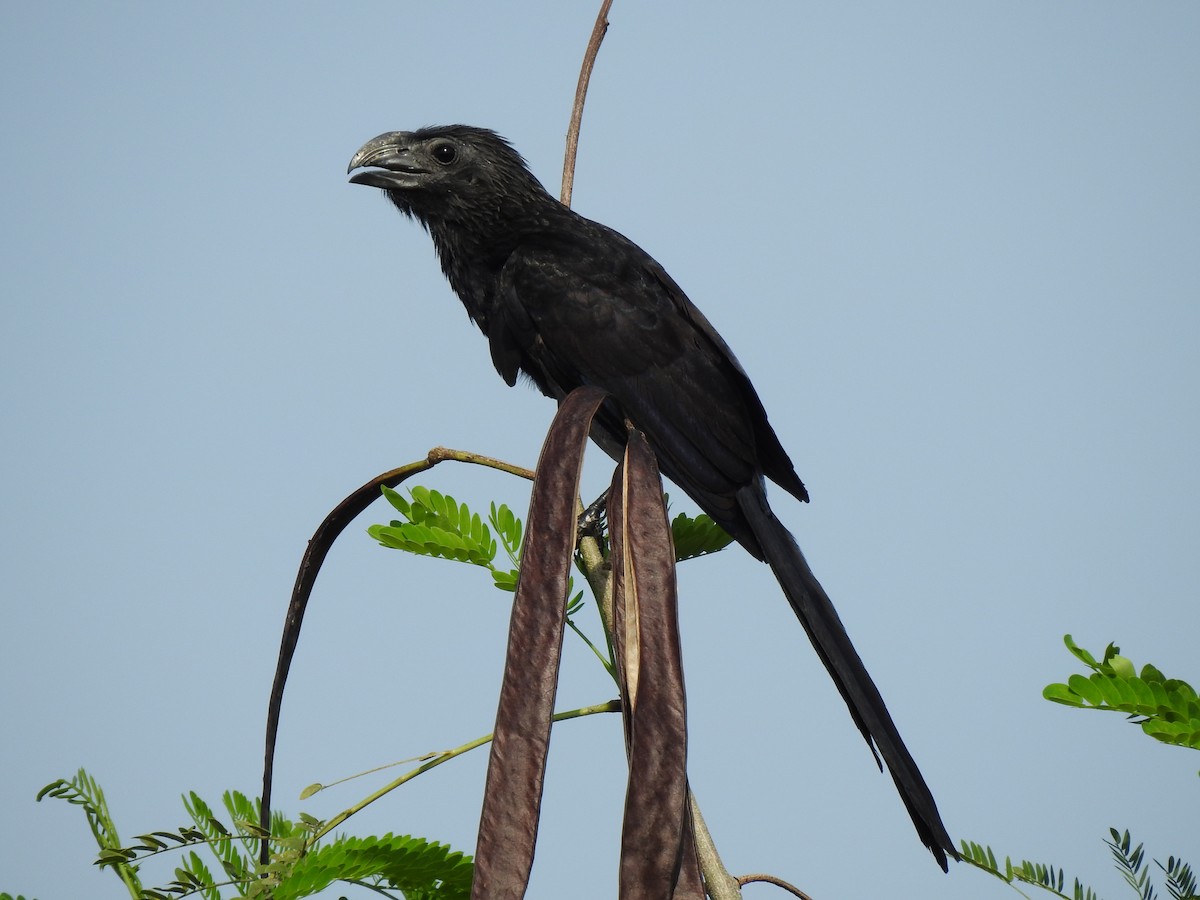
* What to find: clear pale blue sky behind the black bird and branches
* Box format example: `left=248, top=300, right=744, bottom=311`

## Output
left=0, top=0, right=1200, bottom=900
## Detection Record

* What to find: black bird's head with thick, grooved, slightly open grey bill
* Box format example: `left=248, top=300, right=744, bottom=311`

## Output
left=347, top=125, right=548, bottom=226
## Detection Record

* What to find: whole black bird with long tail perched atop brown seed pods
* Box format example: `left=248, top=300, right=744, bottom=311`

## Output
left=348, top=125, right=958, bottom=869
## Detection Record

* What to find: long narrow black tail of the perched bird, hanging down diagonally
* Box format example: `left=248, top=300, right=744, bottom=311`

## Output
left=738, top=485, right=958, bottom=870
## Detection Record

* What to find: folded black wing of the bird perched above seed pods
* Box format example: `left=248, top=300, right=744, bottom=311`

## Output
left=488, top=220, right=804, bottom=550
